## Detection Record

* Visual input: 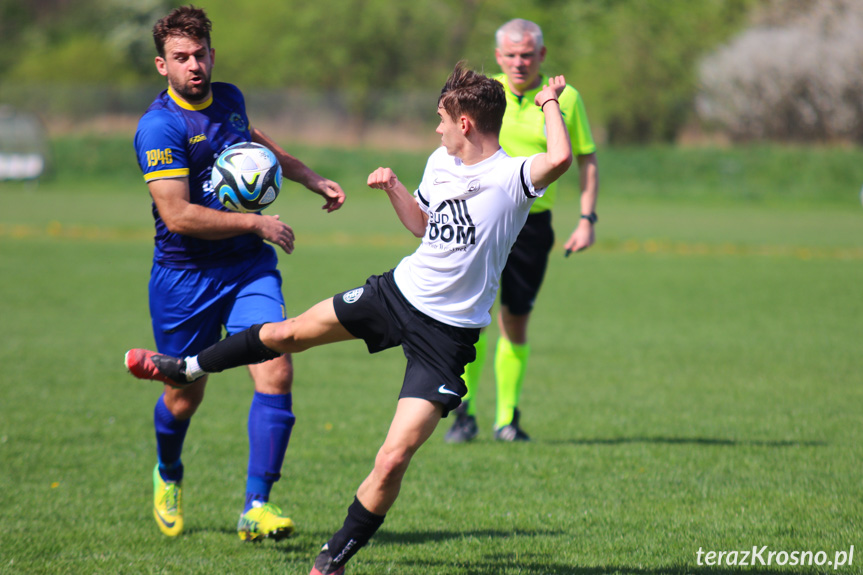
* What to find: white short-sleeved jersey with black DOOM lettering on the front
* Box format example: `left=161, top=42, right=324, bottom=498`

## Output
left=394, top=147, right=545, bottom=328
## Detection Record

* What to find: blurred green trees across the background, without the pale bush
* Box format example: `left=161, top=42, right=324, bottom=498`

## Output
left=0, top=0, right=863, bottom=143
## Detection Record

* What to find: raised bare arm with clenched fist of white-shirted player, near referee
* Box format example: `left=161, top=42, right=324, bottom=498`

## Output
left=530, top=76, right=572, bottom=188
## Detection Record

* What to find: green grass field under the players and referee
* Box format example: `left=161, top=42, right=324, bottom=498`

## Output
left=0, top=139, right=863, bottom=575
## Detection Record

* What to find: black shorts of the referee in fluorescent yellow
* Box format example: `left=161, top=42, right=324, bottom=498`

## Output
left=500, top=210, right=554, bottom=315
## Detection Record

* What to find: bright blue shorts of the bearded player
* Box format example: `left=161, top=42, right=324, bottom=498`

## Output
left=150, top=246, right=286, bottom=357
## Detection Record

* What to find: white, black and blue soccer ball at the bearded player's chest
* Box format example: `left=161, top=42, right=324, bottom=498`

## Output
left=210, top=142, right=282, bottom=212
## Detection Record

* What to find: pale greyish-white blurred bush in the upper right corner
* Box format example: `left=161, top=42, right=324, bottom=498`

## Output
left=697, top=0, right=863, bottom=142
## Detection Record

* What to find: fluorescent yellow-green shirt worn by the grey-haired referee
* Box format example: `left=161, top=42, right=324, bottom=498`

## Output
left=494, top=73, right=596, bottom=214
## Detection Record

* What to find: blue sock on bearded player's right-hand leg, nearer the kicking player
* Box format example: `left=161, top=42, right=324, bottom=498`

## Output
left=243, top=391, right=296, bottom=513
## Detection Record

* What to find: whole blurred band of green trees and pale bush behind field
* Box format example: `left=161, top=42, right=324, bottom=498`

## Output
left=0, top=0, right=863, bottom=144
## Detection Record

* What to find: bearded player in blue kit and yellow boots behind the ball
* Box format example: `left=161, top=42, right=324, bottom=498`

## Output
left=135, top=6, right=345, bottom=541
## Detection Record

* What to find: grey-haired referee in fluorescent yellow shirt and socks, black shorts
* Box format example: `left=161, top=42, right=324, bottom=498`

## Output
left=444, top=19, right=599, bottom=443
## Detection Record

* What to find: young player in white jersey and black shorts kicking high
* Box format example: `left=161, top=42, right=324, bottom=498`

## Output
left=126, top=64, right=572, bottom=575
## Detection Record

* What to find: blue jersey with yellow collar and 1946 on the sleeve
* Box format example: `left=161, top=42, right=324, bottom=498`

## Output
left=135, top=82, right=272, bottom=269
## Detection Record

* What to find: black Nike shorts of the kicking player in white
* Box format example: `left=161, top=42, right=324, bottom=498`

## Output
left=333, top=270, right=480, bottom=417
